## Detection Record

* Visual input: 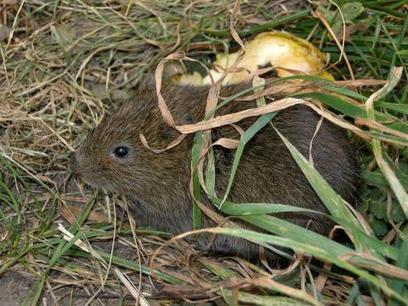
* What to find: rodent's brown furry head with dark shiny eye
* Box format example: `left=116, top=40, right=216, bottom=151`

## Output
left=71, top=93, right=189, bottom=200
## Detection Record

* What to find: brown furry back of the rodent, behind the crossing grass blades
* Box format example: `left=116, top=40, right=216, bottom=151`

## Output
left=159, top=84, right=358, bottom=204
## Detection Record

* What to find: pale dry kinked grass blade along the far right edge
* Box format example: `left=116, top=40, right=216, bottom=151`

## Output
left=366, top=67, right=408, bottom=218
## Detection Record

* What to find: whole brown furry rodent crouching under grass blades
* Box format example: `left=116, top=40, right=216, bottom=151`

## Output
left=72, top=82, right=358, bottom=258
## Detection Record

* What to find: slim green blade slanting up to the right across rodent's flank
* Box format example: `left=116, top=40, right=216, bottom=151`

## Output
left=220, top=113, right=276, bottom=208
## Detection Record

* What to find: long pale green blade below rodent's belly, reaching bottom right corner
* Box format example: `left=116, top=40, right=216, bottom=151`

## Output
left=191, top=227, right=408, bottom=305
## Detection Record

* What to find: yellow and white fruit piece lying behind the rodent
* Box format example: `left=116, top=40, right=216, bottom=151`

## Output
left=177, top=31, right=334, bottom=85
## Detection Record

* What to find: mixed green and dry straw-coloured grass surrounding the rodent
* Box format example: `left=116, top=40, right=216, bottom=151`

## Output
left=0, top=0, right=408, bottom=305
